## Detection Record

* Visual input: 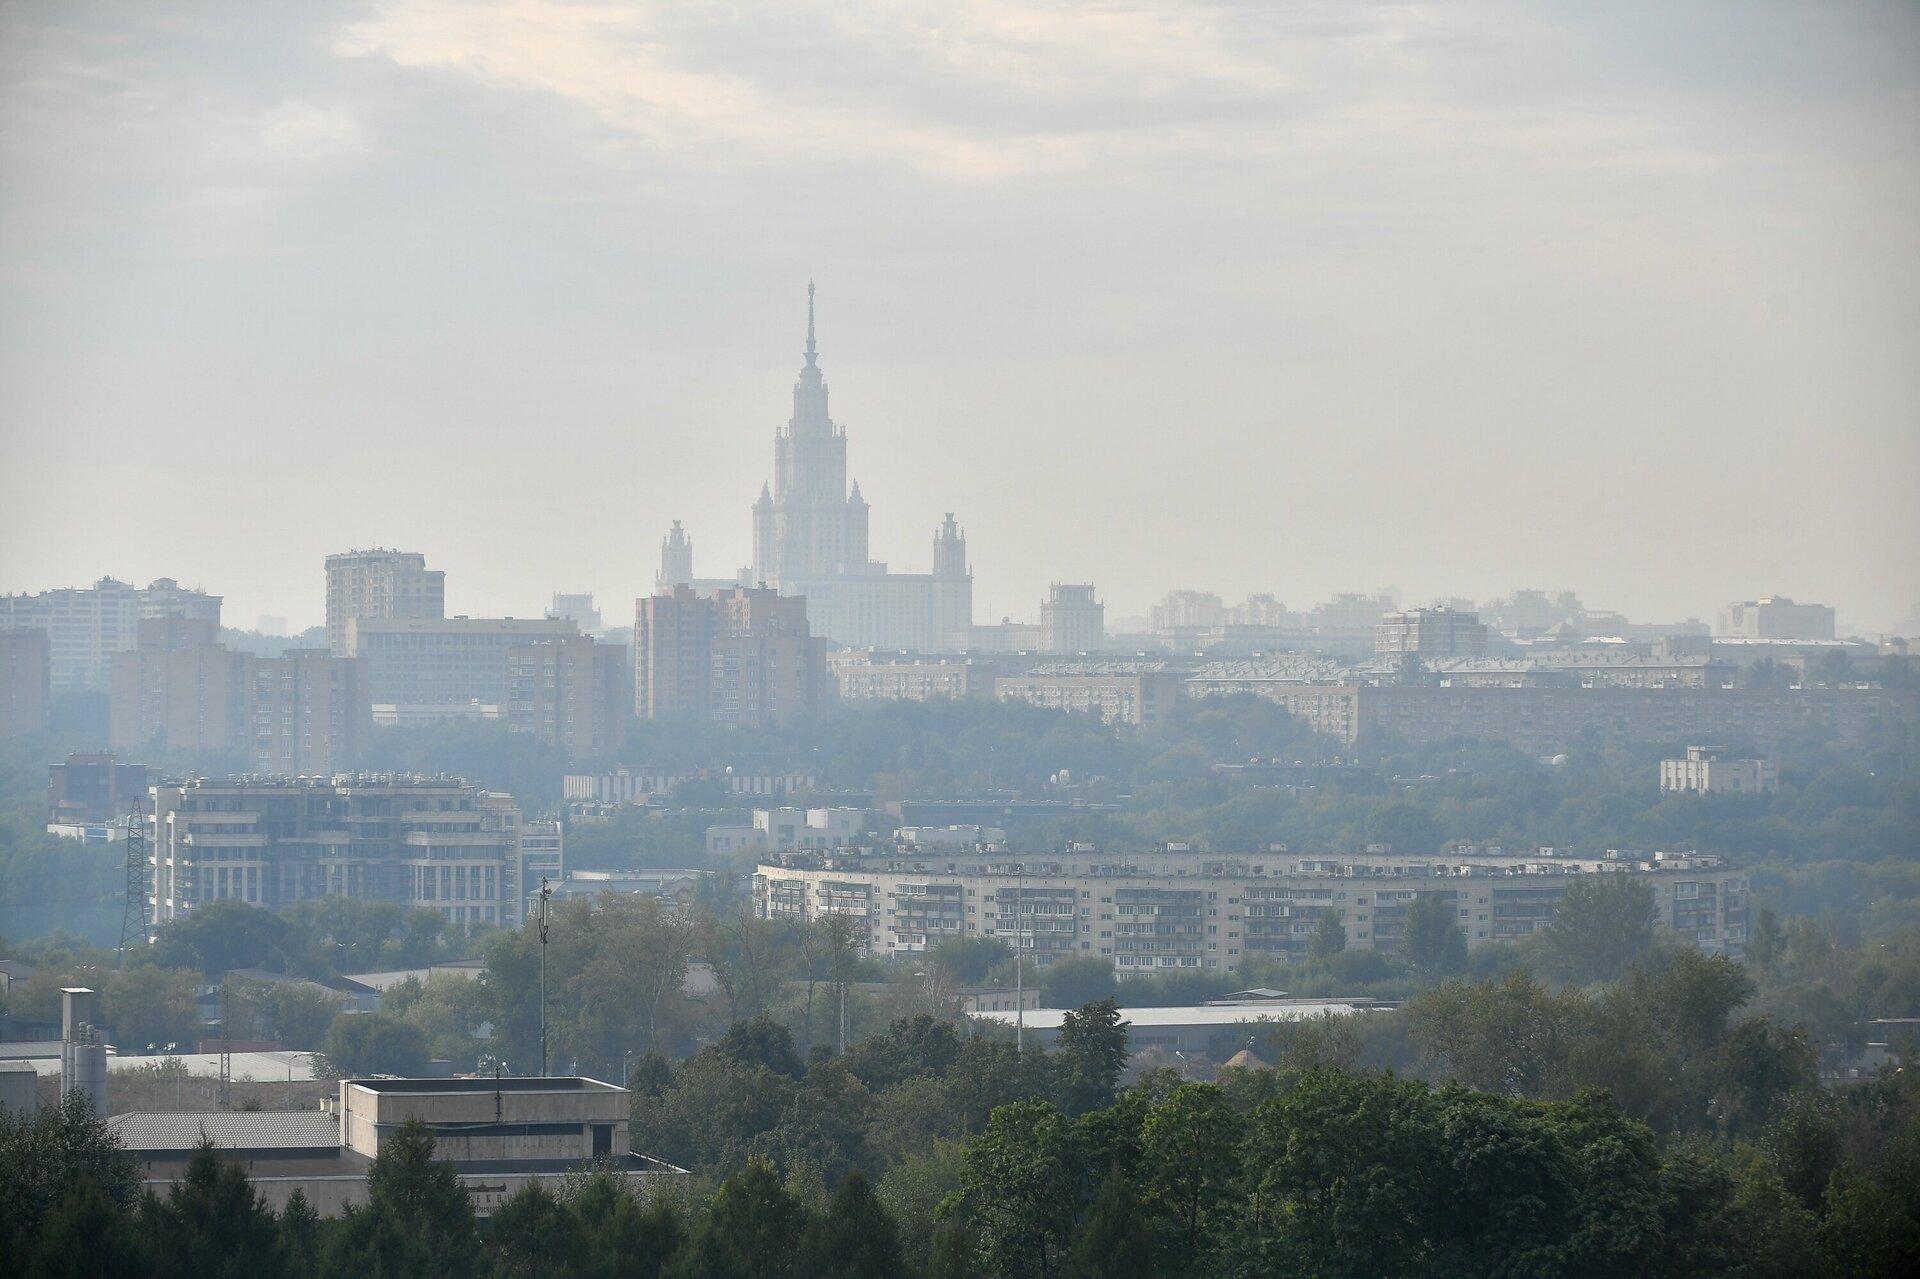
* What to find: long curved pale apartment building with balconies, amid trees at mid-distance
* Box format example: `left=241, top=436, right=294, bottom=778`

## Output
left=753, top=851, right=1749, bottom=977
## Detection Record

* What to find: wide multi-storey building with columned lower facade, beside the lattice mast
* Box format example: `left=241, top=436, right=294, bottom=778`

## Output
left=148, top=774, right=520, bottom=928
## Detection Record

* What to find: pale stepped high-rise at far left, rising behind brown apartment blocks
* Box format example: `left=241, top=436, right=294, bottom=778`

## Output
left=0, top=578, right=221, bottom=693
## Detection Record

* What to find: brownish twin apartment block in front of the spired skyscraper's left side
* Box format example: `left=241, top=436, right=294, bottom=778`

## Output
left=634, top=586, right=829, bottom=728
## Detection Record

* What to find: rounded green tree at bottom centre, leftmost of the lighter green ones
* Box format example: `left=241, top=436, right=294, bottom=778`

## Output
left=960, top=1102, right=1081, bottom=1279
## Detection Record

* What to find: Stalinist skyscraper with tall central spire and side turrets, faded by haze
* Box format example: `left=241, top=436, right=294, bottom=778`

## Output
left=660, top=284, right=973, bottom=653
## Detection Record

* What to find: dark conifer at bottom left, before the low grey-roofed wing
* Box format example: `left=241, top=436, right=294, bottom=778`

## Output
left=140, top=1141, right=286, bottom=1279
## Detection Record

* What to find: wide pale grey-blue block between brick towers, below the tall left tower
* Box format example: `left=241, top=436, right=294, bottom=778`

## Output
left=346, top=616, right=580, bottom=718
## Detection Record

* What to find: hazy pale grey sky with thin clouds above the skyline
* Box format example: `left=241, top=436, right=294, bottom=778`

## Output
left=0, top=0, right=1920, bottom=626
